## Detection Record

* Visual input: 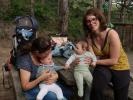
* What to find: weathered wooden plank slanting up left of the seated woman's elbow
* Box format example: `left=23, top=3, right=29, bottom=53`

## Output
left=10, top=67, right=26, bottom=100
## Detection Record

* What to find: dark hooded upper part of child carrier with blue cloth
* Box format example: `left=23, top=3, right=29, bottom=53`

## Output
left=13, top=16, right=38, bottom=48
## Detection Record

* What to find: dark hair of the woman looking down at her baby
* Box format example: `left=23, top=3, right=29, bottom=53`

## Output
left=31, top=37, right=51, bottom=53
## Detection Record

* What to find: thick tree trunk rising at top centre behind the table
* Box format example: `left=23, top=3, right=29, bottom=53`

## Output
left=58, top=0, right=69, bottom=35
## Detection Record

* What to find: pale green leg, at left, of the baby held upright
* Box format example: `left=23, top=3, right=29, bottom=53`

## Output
left=74, top=72, right=84, bottom=97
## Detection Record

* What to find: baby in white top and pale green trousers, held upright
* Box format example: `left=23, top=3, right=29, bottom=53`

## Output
left=65, top=40, right=97, bottom=98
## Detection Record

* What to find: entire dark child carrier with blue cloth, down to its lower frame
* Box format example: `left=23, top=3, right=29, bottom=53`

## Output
left=2, top=16, right=38, bottom=89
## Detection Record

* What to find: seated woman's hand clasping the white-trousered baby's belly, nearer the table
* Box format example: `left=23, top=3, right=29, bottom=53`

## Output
left=44, top=72, right=58, bottom=84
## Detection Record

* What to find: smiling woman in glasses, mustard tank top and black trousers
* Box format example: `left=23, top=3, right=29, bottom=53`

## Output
left=83, top=8, right=130, bottom=100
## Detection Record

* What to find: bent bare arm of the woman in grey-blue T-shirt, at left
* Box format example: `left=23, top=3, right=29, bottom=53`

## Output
left=20, top=69, right=50, bottom=90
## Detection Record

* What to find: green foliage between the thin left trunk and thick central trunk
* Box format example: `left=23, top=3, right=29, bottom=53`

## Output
left=35, top=0, right=59, bottom=33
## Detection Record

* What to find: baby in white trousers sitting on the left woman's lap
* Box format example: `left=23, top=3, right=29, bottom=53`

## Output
left=37, top=53, right=66, bottom=100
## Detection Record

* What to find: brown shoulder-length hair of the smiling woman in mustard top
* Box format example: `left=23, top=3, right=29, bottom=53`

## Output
left=83, top=8, right=107, bottom=36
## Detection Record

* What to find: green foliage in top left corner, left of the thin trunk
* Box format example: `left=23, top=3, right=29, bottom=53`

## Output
left=0, top=0, right=30, bottom=20
